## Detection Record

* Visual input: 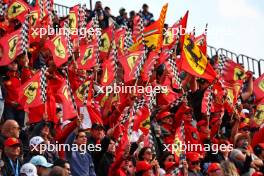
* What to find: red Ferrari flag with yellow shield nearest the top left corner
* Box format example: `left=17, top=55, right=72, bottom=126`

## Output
left=7, top=0, right=30, bottom=23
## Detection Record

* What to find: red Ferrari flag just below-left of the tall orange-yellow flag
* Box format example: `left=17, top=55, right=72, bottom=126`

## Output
left=119, top=51, right=144, bottom=82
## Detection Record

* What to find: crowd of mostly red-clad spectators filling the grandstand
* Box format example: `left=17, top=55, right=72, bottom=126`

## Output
left=0, top=1, right=264, bottom=176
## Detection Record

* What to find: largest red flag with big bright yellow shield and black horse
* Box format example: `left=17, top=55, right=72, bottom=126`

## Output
left=181, top=34, right=216, bottom=81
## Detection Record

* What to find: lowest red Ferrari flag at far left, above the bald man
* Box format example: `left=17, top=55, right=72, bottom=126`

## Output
left=19, top=71, right=43, bottom=109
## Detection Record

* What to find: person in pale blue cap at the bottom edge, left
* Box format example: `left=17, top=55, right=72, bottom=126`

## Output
left=30, top=155, right=53, bottom=176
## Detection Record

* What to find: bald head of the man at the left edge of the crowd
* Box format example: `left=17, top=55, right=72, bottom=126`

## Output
left=1, top=120, right=20, bottom=138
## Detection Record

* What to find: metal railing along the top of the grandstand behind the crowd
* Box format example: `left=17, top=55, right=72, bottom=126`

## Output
left=54, top=3, right=264, bottom=77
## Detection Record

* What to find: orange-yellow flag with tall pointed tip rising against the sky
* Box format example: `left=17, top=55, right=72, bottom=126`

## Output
left=130, top=4, right=168, bottom=51
